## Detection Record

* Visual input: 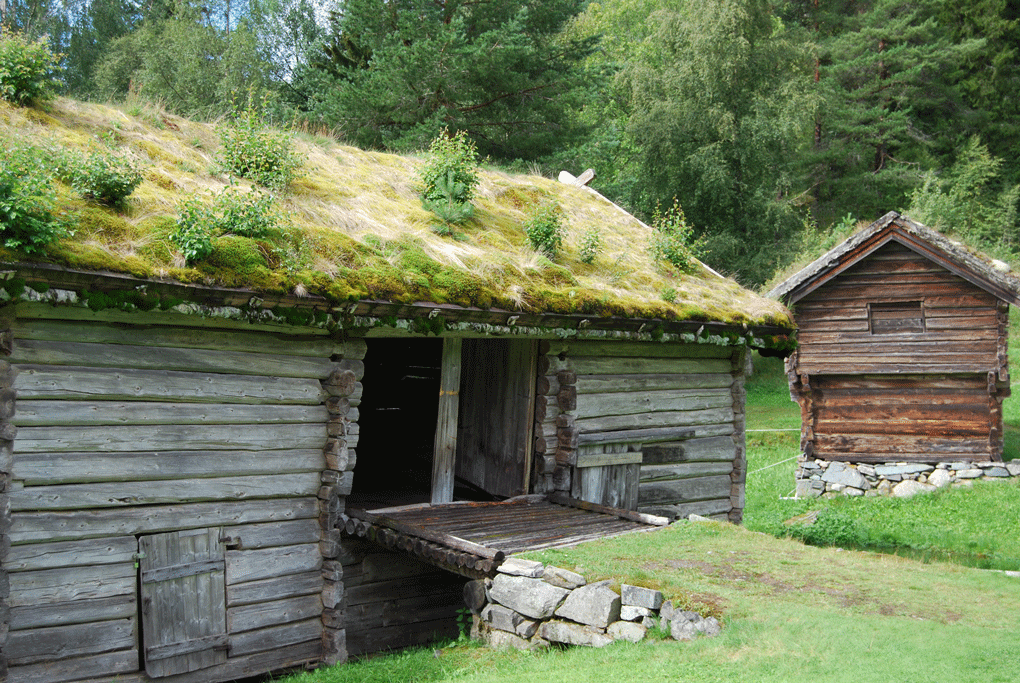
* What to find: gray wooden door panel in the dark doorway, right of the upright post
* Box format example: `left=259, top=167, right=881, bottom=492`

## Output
left=455, top=339, right=538, bottom=497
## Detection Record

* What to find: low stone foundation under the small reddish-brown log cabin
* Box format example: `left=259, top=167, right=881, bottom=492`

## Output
left=796, top=458, right=1020, bottom=498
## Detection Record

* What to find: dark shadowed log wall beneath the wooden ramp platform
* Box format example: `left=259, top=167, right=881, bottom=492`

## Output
left=340, top=536, right=467, bottom=655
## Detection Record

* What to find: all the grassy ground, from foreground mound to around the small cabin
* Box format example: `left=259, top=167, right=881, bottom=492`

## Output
left=275, top=340, right=1020, bottom=683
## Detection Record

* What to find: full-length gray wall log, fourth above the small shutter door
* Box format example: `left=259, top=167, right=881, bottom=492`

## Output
left=11, top=424, right=326, bottom=453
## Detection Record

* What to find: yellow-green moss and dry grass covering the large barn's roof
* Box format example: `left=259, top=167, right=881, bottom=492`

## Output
left=0, top=99, right=793, bottom=327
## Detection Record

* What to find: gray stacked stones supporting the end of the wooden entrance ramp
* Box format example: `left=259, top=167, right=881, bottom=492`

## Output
left=464, top=558, right=720, bottom=649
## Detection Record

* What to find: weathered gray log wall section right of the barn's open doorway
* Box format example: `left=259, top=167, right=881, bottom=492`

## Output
left=536, top=342, right=746, bottom=522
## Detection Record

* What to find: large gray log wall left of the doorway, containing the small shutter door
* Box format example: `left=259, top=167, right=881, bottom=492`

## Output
left=0, top=306, right=364, bottom=683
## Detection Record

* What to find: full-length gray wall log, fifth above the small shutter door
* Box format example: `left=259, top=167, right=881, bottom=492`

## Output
left=11, top=397, right=328, bottom=427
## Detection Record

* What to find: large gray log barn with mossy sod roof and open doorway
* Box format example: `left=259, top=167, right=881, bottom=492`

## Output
left=0, top=100, right=793, bottom=683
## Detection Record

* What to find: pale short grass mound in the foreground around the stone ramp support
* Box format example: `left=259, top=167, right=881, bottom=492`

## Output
left=279, top=522, right=1020, bottom=683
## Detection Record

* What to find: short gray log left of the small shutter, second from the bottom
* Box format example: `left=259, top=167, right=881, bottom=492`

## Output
left=5, top=617, right=138, bottom=667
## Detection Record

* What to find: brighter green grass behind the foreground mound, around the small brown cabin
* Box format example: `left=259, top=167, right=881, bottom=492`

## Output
left=745, top=352, right=1020, bottom=570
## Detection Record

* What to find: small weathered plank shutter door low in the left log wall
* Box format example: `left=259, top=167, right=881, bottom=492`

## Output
left=140, top=528, right=226, bottom=677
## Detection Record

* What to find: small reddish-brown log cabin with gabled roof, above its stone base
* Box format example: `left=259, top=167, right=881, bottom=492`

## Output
left=770, top=212, right=1020, bottom=464
